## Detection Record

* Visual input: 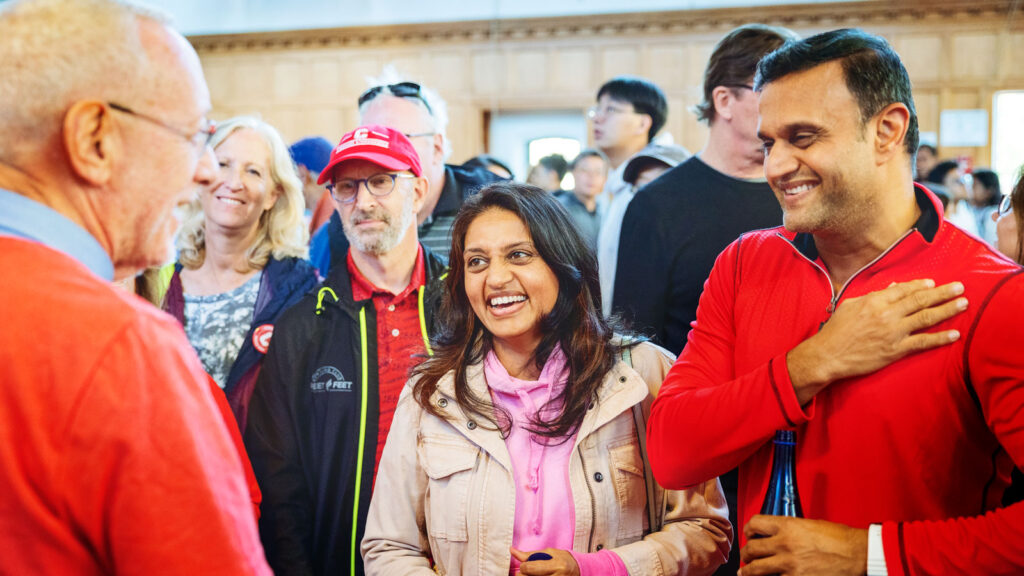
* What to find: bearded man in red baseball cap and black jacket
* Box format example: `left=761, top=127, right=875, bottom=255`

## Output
left=245, top=126, right=445, bottom=574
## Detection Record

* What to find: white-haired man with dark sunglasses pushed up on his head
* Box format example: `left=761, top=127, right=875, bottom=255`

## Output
left=309, top=77, right=501, bottom=276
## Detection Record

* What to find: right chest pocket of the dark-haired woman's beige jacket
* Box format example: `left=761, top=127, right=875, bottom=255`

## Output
left=608, top=438, right=647, bottom=544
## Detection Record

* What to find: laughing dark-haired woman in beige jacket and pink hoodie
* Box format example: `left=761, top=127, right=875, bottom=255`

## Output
left=362, top=182, right=731, bottom=576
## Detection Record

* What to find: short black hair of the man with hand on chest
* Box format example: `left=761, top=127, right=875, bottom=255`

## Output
left=754, top=29, right=920, bottom=158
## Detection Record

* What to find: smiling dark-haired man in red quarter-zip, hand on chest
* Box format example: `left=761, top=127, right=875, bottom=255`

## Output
left=648, top=31, right=1024, bottom=575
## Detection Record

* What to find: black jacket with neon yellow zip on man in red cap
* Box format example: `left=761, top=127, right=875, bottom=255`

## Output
left=245, top=248, right=445, bottom=576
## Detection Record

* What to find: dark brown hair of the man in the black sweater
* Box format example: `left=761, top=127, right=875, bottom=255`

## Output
left=693, top=24, right=800, bottom=124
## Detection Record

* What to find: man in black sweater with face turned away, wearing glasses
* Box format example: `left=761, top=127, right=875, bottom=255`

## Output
left=611, top=24, right=797, bottom=576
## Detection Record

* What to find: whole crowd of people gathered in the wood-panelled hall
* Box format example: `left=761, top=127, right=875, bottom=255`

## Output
left=0, top=0, right=1024, bottom=576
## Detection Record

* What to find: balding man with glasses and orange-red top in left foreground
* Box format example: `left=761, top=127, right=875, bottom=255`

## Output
left=0, top=0, right=269, bottom=574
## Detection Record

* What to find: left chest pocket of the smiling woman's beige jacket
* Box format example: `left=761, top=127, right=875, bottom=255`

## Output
left=417, top=437, right=479, bottom=542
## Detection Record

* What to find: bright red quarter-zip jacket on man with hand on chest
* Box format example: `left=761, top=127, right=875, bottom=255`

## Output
left=648, top=189, right=1024, bottom=576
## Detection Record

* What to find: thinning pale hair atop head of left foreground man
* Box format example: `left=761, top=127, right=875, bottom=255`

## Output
left=0, top=0, right=170, bottom=158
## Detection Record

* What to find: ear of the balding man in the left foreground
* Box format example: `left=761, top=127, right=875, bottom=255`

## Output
left=61, top=100, right=120, bottom=184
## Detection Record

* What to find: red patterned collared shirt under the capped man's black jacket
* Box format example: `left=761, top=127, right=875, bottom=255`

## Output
left=347, top=246, right=427, bottom=483
